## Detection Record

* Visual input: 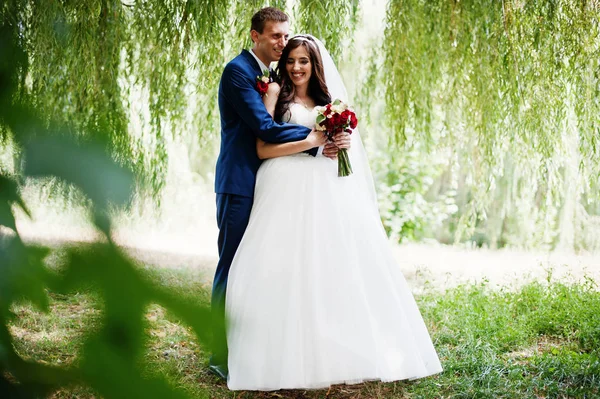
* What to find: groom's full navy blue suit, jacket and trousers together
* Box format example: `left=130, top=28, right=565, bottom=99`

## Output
left=211, top=50, right=317, bottom=365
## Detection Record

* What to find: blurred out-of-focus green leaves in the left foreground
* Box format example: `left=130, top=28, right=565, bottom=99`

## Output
left=0, top=18, right=210, bottom=399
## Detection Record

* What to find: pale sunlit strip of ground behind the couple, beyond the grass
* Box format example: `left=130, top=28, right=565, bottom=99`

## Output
left=19, top=217, right=600, bottom=292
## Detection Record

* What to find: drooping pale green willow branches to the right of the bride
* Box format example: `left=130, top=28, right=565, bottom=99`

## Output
left=381, top=0, right=600, bottom=247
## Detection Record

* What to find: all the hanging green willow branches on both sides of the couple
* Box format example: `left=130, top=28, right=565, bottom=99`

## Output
left=0, top=0, right=600, bottom=250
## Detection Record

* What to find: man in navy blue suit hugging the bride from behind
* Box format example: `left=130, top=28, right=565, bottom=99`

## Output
left=209, top=7, right=337, bottom=379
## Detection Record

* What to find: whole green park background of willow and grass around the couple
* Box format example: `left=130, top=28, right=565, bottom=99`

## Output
left=0, top=0, right=600, bottom=397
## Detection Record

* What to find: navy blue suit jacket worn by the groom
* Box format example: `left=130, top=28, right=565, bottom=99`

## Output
left=215, top=50, right=317, bottom=197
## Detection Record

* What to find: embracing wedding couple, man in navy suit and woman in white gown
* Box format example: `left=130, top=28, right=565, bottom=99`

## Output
left=210, top=7, right=441, bottom=390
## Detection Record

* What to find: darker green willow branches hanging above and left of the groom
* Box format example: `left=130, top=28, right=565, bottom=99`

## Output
left=0, top=0, right=357, bottom=189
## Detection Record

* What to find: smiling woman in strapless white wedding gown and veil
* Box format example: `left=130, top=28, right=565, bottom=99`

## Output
left=226, top=35, right=442, bottom=390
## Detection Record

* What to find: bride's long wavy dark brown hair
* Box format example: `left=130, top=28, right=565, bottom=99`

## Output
left=275, top=35, right=331, bottom=122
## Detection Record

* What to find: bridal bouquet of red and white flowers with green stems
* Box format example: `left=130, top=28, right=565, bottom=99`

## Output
left=316, top=99, right=358, bottom=177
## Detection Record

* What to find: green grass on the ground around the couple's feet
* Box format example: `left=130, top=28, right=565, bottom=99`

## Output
left=11, top=268, right=600, bottom=399
